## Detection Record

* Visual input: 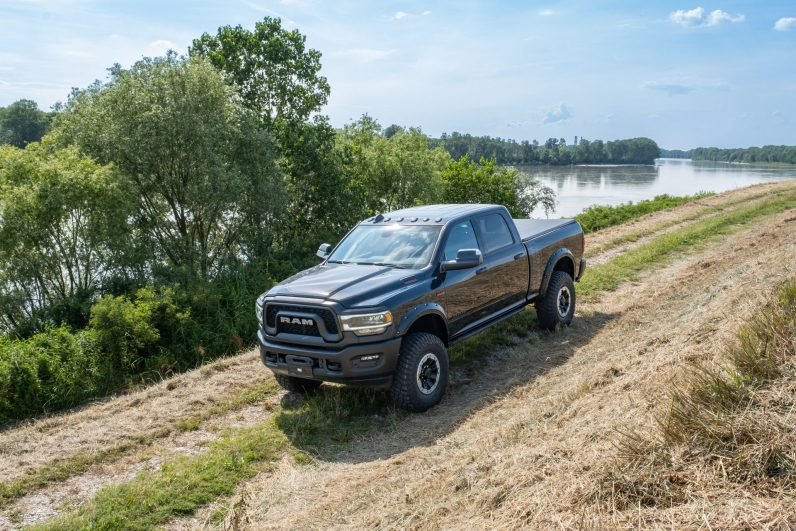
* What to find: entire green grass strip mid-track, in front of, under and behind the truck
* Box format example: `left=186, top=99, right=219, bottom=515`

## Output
left=31, top=187, right=796, bottom=529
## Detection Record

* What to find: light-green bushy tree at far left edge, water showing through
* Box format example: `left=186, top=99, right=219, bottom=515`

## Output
left=0, top=143, right=133, bottom=335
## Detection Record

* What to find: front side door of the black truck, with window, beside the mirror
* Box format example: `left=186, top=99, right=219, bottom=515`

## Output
left=440, top=220, right=483, bottom=336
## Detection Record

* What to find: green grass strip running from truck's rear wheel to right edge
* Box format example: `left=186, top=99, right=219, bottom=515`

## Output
left=578, top=192, right=796, bottom=299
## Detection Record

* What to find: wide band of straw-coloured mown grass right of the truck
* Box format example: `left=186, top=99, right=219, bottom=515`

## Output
left=225, top=203, right=796, bottom=529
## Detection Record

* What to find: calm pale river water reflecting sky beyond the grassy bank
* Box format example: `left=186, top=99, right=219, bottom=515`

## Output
left=517, top=159, right=796, bottom=218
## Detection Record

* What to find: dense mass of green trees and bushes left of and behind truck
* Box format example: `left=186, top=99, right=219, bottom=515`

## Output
left=0, top=17, right=555, bottom=423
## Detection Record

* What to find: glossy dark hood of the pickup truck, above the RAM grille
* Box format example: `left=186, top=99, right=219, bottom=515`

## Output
left=267, top=264, right=418, bottom=308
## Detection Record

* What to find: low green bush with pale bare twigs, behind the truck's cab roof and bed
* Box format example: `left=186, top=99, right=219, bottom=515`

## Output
left=441, top=155, right=555, bottom=218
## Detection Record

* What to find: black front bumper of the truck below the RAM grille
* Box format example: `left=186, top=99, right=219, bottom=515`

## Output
left=257, top=329, right=401, bottom=385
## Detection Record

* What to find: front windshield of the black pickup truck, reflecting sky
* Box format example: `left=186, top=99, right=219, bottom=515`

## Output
left=328, top=224, right=440, bottom=269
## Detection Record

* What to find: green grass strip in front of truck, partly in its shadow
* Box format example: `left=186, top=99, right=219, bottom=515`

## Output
left=40, top=386, right=402, bottom=529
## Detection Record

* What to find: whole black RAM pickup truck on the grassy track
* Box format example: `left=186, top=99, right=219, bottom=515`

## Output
left=256, top=204, right=586, bottom=411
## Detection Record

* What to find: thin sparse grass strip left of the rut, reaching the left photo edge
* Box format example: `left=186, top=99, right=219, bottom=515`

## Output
left=0, top=380, right=278, bottom=507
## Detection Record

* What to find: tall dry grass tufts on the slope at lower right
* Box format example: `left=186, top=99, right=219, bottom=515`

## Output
left=596, top=282, right=796, bottom=527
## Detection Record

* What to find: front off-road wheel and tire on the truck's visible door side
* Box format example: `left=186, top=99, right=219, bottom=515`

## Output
left=391, top=332, right=448, bottom=413
